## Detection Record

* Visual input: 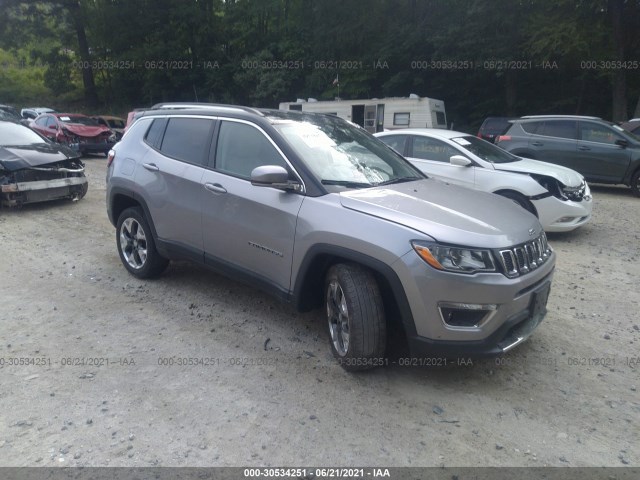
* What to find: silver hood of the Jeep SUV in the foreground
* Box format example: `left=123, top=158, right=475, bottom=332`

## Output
left=340, top=179, right=542, bottom=248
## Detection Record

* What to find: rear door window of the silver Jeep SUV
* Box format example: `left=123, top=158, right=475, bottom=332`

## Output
left=158, top=118, right=213, bottom=165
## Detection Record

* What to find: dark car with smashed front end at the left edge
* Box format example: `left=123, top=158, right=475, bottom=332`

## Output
left=0, top=121, right=88, bottom=207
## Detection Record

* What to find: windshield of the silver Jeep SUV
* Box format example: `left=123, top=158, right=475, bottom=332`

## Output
left=274, top=115, right=425, bottom=190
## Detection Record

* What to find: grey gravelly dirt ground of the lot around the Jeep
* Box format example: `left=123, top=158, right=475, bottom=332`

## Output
left=0, top=157, right=640, bottom=467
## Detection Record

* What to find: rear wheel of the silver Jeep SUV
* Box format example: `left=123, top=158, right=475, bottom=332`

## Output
left=116, top=207, right=169, bottom=278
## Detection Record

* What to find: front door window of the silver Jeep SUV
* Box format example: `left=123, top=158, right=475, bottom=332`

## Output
left=215, top=121, right=288, bottom=179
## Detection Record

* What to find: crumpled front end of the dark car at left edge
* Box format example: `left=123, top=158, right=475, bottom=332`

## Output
left=0, top=159, right=88, bottom=207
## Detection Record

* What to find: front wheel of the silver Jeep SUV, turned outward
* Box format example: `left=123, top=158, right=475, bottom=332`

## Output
left=324, top=263, right=387, bottom=371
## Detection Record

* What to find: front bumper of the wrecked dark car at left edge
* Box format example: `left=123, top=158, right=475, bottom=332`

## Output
left=0, top=176, right=88, bottom=207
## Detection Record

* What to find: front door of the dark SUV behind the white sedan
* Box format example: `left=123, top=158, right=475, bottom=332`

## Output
left=576, top=120, right=631, bottom=183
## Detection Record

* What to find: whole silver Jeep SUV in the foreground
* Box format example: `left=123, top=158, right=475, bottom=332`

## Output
left=107, top=104, right=555, bottom=370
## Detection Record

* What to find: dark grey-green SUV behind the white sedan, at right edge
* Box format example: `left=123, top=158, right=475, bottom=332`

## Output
left=496, top=115, right=640, bottom=196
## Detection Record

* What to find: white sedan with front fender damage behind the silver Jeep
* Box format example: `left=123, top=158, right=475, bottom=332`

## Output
left=375, top=129, right=593, bottom=232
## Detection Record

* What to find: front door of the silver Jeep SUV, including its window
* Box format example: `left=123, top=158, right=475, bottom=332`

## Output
left=200, top=120, right=304, bottom=293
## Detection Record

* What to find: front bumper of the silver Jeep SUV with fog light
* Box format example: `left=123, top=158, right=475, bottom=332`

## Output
left=396, top=248, right=555, bottom=357
